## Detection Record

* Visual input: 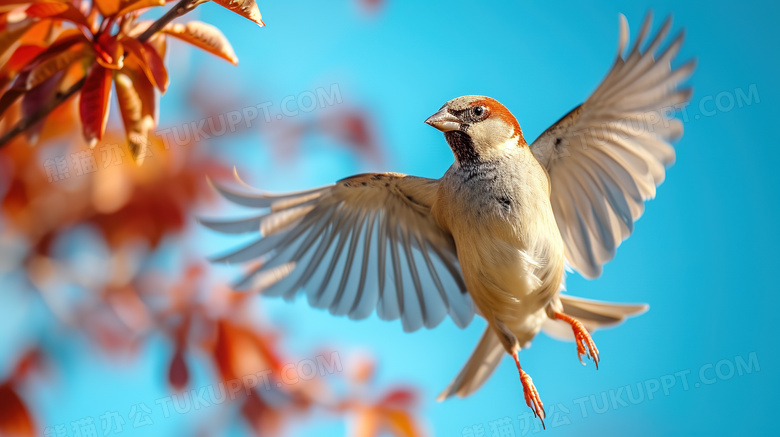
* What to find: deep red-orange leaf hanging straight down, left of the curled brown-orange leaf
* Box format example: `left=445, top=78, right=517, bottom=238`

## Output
left=79, top=64, right=111, bottom=147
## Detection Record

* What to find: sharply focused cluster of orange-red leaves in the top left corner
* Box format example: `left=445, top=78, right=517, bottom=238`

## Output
left=0, top=0, right=263, bottom=159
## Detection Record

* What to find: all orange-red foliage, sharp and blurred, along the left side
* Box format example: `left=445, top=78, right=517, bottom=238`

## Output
left=0, top=0, right=422, bottom=436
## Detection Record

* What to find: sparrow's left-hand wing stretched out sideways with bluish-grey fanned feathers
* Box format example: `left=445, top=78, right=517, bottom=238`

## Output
left=201, top=169, right=474, bottom=331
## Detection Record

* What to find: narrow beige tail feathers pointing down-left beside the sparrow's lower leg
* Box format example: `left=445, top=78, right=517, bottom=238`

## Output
left=436, top=326, right=506, bottom=401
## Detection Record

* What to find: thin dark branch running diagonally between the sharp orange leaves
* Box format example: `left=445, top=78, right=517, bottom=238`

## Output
left=0, top=0, right=204, bottom=147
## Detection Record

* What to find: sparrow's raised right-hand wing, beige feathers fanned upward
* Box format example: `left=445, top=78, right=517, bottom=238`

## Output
left=531, top=15, right=695, bottom=278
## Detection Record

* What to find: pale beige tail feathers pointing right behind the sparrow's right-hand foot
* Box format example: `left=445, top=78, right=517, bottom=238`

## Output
left=542, top=294, right=649, bottom=340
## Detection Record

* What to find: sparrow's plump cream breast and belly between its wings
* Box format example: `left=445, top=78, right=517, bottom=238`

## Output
left=434, top=157, right=564, bottom=338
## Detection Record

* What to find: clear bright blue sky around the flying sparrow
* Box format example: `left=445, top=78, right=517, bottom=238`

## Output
left=12, top=0, right=780, bottom=436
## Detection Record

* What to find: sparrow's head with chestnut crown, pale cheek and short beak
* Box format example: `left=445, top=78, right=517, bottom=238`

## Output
left=425, top=96, right=526, bottom=165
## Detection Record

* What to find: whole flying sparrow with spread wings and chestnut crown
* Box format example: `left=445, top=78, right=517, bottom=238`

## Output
left=200, top=13, right=695, bottom=425
